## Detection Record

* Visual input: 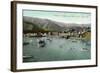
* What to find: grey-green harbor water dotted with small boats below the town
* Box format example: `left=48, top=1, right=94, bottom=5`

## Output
left=23, top=37, right=91, bottom=62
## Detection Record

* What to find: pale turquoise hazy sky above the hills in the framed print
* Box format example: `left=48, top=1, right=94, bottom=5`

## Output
left=23, top=10, right=91, bottom=24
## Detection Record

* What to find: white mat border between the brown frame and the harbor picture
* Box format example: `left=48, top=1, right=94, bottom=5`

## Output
left=16, top=4, right=96, bottom=69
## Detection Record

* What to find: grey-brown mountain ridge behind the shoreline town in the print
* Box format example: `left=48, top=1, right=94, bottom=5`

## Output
left=23, top=16, right=90, bottom=31
